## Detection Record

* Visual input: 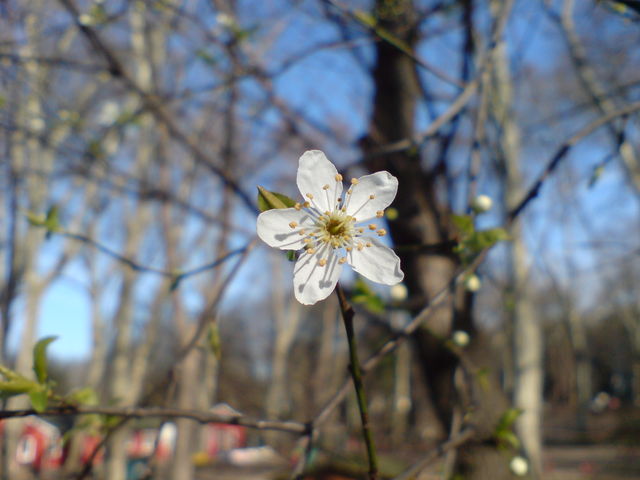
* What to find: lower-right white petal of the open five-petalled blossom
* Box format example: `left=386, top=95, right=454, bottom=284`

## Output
left=347, top=237, right=404, bottom=285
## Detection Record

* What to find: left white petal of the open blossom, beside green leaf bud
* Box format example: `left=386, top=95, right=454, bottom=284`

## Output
left=257, top=208, right=314, bottom=250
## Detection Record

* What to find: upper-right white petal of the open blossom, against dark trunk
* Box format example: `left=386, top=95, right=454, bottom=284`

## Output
left=345, top=171, right=398, bottom=222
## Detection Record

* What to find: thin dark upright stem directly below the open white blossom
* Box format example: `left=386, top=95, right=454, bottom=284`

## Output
left=336, top=283, right=378, bottom=480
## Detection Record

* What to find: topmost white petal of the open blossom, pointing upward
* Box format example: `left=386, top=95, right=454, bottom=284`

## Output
left=296, top=150, right=342, bottom=213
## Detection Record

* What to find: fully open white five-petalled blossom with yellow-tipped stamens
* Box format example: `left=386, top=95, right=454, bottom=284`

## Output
left=257, top=150, right=404, bottom=305
